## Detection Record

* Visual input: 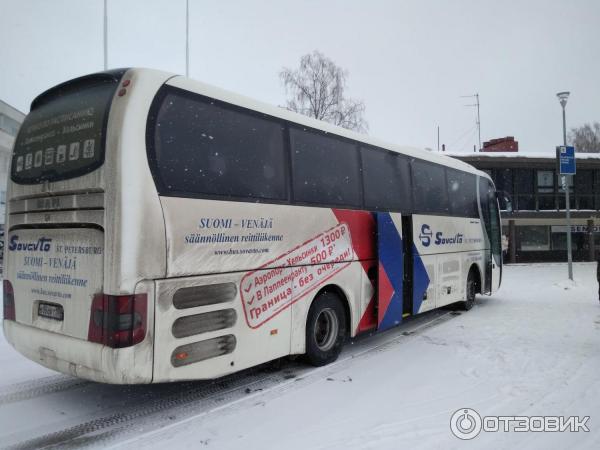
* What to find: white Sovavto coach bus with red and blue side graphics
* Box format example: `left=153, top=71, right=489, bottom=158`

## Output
left=3, top=69, right=502, bottom=383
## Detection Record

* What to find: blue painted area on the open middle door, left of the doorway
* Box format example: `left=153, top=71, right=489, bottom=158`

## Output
left=377, top=213, right=404, bottom=330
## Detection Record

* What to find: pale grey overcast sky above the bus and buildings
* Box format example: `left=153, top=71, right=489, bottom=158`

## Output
left=0, top=0, right=600, bottom=152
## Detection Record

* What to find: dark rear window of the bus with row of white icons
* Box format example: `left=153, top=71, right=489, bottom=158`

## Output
left=11, top=75, right=118, bottom=184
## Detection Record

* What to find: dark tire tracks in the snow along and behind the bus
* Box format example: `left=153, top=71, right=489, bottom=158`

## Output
left=0, top=311, right=453, bottom=450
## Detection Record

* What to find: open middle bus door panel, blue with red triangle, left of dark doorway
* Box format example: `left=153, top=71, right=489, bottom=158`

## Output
left=376, top=213, right=407, bottom=331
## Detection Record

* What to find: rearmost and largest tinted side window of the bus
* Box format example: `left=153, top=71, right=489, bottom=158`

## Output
left=148, top=87, right=287, bottom=201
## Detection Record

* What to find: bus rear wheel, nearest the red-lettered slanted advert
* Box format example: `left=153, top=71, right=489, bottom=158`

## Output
left=306, top=292, right=346, bottom=366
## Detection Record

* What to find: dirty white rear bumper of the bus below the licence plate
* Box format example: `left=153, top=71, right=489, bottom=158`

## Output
left=3, top=320, right=152, bottom=384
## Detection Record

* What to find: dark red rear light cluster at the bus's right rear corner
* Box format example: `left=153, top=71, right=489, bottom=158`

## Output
left=88, top=294, right=148, bottom=348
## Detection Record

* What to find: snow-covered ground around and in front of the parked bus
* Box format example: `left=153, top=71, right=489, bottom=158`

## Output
left=0, top=264, right=600, bottom=449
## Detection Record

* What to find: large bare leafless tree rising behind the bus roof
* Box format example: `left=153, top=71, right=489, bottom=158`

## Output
left=279, top=50, right=369, bottom=133
